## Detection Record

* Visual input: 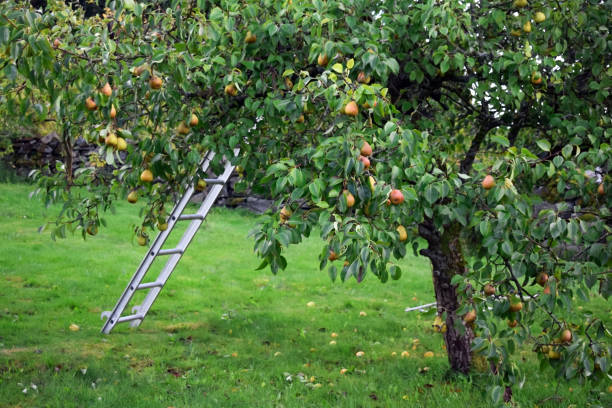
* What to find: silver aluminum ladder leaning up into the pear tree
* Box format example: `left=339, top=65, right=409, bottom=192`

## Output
left=101, top=149, right=239, bottom=334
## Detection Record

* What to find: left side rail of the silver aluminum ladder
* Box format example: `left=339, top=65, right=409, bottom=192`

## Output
left=102, top=151, right=215, bottom=334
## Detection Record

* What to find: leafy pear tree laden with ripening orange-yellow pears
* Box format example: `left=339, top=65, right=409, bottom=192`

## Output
left=0, top=0, right=612, bottom=402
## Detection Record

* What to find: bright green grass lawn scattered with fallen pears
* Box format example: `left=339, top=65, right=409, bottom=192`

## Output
left=0, top=184, right=610, bottom=407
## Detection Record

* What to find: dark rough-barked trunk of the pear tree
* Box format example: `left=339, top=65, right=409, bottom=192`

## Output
left=419, top=221, right=474, bottom=373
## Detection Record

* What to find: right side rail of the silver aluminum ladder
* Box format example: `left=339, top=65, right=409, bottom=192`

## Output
left=130, top=149, right=239, bottom=327
